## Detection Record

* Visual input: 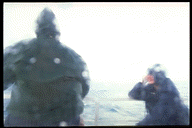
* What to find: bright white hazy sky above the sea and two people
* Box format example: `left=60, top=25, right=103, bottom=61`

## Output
left=3, top=2, right=189, bottom=81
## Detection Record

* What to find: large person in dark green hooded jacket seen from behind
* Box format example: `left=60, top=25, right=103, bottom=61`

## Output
left=4, top=8, right=89, bottom=126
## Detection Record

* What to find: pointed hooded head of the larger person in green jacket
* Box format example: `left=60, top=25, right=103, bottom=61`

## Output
left=35, top=8, right=60, bottom=38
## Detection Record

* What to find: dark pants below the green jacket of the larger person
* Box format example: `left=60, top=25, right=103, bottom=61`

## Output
left=4, top=114, right=80, bottom=127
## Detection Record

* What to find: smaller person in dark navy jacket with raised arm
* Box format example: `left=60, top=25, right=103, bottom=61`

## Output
left=128, top=64, right=189, bottom=125
